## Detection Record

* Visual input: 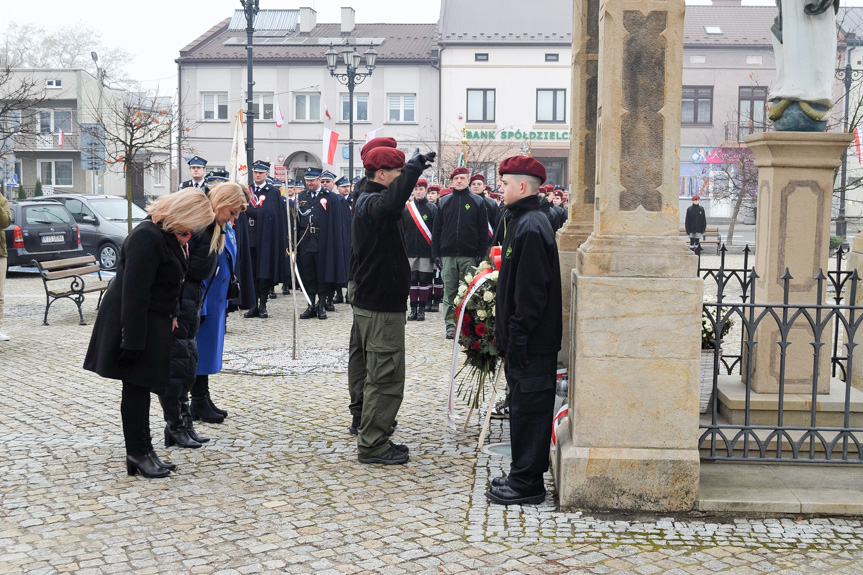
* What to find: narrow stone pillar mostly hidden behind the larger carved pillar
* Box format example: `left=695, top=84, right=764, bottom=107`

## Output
left=557, top=0, right=599, bottom=366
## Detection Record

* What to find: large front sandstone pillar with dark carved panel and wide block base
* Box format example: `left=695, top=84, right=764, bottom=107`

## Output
left=553, top=0, right=703, bottom=511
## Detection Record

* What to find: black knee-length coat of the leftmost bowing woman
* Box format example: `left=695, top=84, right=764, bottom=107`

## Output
left=84, top=217, right=188, bottom=393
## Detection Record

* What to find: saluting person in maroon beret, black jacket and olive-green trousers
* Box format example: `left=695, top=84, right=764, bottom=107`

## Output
left=348, top=140, right=435, bottom=465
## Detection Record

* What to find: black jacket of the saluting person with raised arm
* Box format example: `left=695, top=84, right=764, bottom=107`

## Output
left=351, top=162, right=422, bottom=312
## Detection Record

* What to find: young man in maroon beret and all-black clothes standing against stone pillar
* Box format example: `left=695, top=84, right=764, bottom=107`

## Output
left=486, top=156, right=563, bottom=505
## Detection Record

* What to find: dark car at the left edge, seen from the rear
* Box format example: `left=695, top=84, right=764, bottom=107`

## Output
left=3, top=200, right=84, bottom=266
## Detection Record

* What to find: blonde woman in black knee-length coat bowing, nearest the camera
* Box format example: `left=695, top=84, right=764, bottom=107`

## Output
left=84, top=188, right=213, bottom=477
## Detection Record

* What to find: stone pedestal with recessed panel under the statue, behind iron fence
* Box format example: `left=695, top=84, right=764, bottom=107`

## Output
left=743, top=132, right=853, bottom=394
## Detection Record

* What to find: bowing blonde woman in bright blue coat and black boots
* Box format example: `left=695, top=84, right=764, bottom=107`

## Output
left=191, top=182, right=248, bottom=423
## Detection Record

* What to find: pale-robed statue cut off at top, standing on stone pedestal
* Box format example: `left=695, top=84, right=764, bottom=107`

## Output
left=770, top=0, right=839, bottom=132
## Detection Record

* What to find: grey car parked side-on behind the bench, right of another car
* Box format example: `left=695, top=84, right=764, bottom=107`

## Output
left=31, top=194, right=147, bottom=270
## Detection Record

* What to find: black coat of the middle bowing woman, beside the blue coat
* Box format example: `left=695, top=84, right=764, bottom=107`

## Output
left=167, top=222, right=219, bottom=397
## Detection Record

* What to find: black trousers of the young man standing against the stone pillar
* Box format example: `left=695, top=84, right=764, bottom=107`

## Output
left=506, top=354, right=557, bottom=495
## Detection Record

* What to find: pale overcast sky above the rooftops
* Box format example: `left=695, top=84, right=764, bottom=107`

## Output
left=2, top=0, right=863, bottom=94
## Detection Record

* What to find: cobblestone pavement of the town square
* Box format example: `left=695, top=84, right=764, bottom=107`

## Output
left=0, top=274, right=863, bottom=575
